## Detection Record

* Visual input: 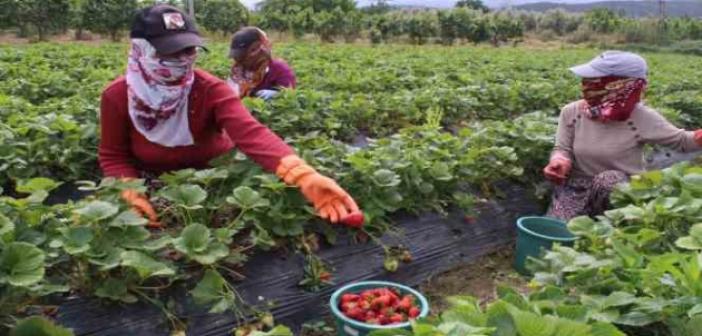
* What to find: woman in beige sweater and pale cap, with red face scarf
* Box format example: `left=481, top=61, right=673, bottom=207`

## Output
left=544, top=51, right=702, bottom=221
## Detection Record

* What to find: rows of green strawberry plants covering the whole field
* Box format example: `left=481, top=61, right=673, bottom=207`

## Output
left=0, top=43, right=702, bottom=336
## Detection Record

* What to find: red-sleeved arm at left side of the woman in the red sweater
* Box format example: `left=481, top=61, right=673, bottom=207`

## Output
left=98, top=86, right=139, bottom=178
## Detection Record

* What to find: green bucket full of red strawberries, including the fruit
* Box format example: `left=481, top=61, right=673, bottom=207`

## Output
left=329, top=281, right=429, bottom=336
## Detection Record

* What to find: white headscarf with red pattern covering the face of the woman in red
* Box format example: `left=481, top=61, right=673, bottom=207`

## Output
left=126, top=39, right=197, bottom=147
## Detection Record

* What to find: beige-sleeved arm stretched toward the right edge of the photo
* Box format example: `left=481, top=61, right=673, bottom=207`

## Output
left=644, top=107, right=702, bottom=152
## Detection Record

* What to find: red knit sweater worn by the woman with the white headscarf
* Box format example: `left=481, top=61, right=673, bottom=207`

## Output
left=98, top=69, right=293, bottom=177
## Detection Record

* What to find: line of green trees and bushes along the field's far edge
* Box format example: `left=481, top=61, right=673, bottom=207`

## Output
left=0, top=0, right=702, bottom=45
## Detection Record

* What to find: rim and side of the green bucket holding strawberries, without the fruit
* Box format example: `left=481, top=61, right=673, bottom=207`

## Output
left=329, top=281, right=429, bottom=336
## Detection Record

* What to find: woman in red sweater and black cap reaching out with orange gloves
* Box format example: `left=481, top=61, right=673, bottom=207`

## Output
left=98, top=5, right=360, bottom=225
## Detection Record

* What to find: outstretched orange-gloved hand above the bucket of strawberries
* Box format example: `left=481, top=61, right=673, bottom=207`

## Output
left=276, top=155, right=363, bottom=227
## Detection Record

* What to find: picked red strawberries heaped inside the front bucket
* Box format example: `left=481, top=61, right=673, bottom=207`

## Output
left=339, top=287, right=420, bottom=325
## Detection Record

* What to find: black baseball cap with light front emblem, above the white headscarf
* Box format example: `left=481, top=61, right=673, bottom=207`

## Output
left=129, top=4, right=202, bottom=54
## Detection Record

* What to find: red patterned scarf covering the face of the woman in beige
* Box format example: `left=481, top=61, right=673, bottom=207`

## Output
left=582, top=76, right=647, bottom=122
